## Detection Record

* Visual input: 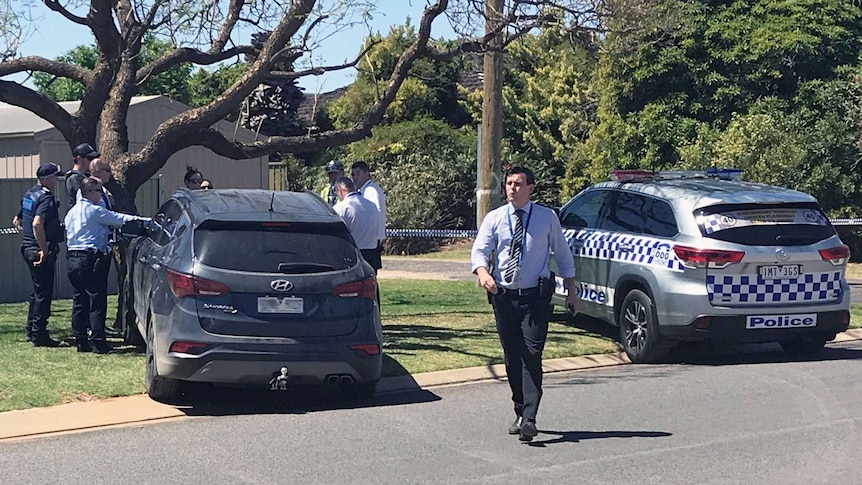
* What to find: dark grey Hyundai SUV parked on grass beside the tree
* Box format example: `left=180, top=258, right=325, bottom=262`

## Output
left=124, top=189, right=382, bottom=401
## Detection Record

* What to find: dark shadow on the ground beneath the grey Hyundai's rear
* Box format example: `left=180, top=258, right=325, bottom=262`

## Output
left=170, top=355, right=440, bottom=416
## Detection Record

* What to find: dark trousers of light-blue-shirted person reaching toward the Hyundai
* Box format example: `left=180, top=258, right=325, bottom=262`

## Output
left=66, top=251, right=111, bottom=341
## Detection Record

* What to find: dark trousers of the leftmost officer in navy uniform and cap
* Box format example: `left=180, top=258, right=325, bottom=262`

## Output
left=21, top=246, right=57, bottom=340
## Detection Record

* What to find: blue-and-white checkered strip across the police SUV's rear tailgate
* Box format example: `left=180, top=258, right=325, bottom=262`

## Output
left=706, top=271, right=841, bottom=306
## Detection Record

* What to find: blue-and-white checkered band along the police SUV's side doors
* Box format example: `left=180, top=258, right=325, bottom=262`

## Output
left=564, top=230, right=683, bottom=271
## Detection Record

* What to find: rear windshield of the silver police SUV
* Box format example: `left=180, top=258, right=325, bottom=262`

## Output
left=694, top=202, right=835, bottom=246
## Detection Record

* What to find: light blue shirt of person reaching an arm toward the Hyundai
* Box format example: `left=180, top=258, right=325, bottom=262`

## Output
left=65, top=197, right=148, bottom=253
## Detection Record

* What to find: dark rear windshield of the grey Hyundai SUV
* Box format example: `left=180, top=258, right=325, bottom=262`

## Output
left=194, top=221, right=357, bottom=274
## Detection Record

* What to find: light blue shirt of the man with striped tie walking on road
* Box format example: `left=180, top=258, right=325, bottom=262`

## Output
left=470, top=202, right=575, bottom=289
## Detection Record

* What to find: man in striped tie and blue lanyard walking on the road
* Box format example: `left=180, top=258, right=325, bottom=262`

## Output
left=470, top=167, right=578, bottom=441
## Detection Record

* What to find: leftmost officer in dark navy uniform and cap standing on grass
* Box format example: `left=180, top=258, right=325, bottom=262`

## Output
left=20, top=163, right=63, bottom=347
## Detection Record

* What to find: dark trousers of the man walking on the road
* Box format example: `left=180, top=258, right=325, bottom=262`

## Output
left=490, top=293, right=551, bottom=420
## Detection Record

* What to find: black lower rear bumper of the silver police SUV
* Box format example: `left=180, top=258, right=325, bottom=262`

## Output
left=661, top=311, right=848, bottom=343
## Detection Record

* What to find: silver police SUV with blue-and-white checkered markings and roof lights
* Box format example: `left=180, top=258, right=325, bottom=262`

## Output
left=554, top=169, right=850, bottom=362
